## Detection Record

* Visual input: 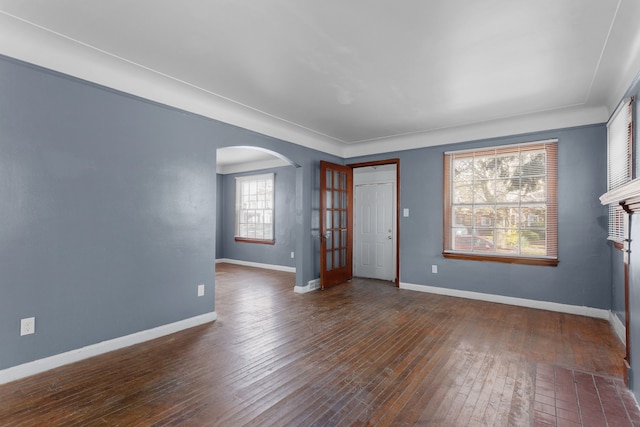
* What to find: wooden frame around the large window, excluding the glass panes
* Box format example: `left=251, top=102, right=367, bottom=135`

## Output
left=442, top=138, right=559, bottom=266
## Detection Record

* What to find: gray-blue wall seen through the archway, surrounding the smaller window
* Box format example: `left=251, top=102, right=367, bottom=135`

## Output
left=216, top=166, right=296, bottom=267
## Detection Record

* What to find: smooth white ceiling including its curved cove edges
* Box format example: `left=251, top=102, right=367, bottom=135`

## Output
left=0, top=0, right=640, bottom=162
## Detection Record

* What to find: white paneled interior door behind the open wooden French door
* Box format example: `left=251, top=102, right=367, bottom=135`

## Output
left=354, top=183, right=396, bottom=281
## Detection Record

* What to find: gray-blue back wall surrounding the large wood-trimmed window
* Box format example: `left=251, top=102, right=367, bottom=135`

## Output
left=349, top=125, right=611, bottom=310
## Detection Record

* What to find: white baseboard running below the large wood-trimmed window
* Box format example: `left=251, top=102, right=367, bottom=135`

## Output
left=400, top=283, right=611, bottom=320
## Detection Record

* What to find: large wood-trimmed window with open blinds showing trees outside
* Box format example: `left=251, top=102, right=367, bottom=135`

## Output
left=443, top=139, right=558, bottom=265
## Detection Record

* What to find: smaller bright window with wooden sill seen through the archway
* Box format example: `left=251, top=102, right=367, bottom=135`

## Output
left=235, top=173, right=275, bottom=244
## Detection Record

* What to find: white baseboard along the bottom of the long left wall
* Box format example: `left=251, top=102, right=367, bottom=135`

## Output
left=0, top=311, right=218, bottom=384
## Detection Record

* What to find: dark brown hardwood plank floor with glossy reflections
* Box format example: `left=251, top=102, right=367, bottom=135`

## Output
left=0, top=264, right=638, bottom=426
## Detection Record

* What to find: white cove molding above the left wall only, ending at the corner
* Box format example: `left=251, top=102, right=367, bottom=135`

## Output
left=0, top=11, right=342, bottom=156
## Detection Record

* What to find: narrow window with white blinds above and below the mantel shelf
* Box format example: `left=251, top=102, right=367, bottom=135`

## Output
left=607, top=98, right=633, bottom=242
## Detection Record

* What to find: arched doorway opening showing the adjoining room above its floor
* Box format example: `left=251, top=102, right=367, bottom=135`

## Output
left=216, top=146, right=302, bottom=290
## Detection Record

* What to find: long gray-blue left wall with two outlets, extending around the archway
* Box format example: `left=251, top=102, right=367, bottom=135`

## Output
left=0, top=57, right=340, bottom=370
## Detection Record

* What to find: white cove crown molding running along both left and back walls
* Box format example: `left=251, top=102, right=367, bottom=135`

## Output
left=0, top=11, right=608, bottom=162
